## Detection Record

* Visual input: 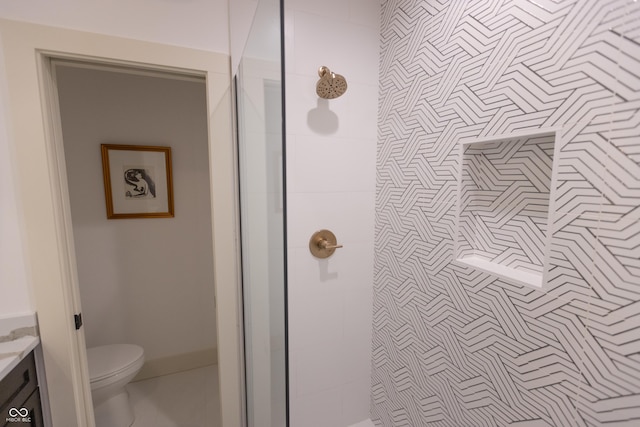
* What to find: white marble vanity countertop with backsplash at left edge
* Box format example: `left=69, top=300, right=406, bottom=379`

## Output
left=0, top=313, right=40, bottom=380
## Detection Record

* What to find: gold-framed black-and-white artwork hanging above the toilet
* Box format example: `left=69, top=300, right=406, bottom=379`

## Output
left=100, top=144, right=174, bottom=219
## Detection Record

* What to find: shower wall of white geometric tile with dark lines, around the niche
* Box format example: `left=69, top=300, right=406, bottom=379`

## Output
left=372, top=0, right=640, bottom=427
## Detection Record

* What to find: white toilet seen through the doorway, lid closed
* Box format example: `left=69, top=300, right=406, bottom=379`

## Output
left=87, top=344, right=144, bottom=427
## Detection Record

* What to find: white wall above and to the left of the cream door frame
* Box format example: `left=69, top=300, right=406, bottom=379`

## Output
left=0, top=0, right=229, bottom=316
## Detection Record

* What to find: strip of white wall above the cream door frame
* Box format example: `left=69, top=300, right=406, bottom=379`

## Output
left=0, top=0, right=229, bottom=53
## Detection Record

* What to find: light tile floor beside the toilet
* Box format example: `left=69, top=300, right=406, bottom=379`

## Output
left=127, top=365, right=220, bottom=427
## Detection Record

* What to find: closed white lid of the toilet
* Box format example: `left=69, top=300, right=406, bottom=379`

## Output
left=87, top=344, right=144, bottom=381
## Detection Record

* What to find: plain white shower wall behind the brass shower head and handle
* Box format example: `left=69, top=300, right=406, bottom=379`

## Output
left=285, top=0, right=380, bottom=427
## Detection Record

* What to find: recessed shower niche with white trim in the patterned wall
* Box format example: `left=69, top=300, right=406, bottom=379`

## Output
left=454, top=129, right=559, bottom=288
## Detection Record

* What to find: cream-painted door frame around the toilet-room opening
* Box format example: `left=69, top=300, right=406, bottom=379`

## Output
left=0, top=21, right=242, bottom=427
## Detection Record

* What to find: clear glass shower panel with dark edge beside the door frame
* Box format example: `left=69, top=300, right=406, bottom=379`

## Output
left=236, top=0, right=288, bottom=427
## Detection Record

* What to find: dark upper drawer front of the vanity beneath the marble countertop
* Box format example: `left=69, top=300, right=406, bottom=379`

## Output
left=0, top=352, right=38, bottom=425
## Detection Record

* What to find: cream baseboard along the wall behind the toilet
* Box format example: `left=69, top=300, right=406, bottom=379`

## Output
left=133, top=347, right=218, bottom=381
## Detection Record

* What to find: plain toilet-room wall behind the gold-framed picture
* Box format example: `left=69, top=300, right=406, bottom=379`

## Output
left=57, top=67, right=216, bottom=360
